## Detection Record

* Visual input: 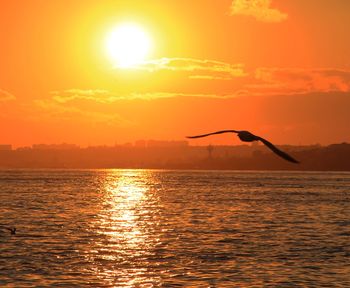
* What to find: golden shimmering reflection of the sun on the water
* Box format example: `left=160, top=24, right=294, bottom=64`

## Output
left=89, top=170, right=164, bottom=287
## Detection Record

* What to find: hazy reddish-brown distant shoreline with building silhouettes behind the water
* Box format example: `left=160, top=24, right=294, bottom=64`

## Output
left=0, top=143, right=350, bottom=171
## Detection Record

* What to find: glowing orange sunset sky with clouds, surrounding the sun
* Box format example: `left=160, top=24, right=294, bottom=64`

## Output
left=0, top=0, right=350, bottom=147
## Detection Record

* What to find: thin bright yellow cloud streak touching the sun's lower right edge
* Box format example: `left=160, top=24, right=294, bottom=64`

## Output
left=115, top=58, right=246, bottom=79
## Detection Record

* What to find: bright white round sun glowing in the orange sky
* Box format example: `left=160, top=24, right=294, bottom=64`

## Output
left=106, top=23, right=152, bottom=68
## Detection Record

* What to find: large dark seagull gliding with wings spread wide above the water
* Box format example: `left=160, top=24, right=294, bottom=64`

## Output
left=186, top=130, right=299, bottom=163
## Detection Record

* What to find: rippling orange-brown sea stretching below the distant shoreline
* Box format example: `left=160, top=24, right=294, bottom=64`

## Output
left=0, top=170, right=350, bottom=287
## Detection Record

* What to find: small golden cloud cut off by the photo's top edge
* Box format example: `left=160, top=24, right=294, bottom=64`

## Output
left=231, top=0, right=288, bottom=22
